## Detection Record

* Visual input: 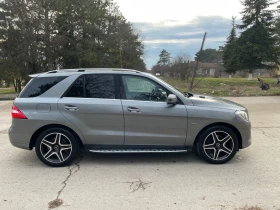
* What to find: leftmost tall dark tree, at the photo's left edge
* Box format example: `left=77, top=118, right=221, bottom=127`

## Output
left=0, top=0, right=40, bottom=92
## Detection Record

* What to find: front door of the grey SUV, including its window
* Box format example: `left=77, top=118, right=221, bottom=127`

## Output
left=121, top=75, right=188, bottom=146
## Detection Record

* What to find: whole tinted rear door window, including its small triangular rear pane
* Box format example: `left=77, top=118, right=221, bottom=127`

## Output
left=66, top=74, right=116, bottom=99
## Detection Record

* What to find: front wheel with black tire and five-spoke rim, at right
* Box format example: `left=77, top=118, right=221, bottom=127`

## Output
left=196, top=126, right=239, bottom=164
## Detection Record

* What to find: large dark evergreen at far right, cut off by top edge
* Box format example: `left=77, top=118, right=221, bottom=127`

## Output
left=234, top=0, right=279, bottom=73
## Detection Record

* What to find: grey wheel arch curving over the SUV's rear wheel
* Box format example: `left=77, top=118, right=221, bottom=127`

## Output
left=29, top=124, right=84, bottom=150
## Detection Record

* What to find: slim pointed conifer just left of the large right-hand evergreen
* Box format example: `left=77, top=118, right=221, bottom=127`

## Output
left=222, top=17, right=239, bottom=73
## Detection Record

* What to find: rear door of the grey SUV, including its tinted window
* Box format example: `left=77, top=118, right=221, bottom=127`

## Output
left=58, top=74, right=124, bottom=146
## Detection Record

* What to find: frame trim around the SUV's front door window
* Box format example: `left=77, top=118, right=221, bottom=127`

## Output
left=118, top=74, right=184, bottom=105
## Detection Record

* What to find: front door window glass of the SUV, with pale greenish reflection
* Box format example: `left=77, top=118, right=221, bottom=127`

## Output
left=122, top=76, right=168, bottom=102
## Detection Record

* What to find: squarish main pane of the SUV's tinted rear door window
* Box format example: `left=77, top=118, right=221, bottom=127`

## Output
left=85, top=74, right=116, bottom=99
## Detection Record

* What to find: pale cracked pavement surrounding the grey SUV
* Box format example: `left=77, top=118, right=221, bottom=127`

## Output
left=0, top=97, right=280, bottom=210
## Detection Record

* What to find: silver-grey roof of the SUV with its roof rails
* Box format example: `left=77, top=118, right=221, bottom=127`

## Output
left=29, top=68, right=141, bottom=77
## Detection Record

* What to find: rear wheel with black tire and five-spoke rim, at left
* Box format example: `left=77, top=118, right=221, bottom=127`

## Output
left=35, top=128, right=79, bottom=167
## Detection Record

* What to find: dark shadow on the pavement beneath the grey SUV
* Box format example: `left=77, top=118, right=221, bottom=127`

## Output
left=10, top=149, right=243, bottom=168
